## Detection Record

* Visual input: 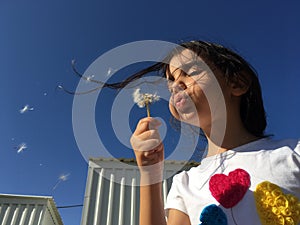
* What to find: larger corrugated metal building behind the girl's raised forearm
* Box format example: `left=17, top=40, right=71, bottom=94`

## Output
left=81, top=158, right=197, bottom=225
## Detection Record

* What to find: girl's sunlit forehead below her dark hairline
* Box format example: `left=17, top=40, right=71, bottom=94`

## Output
left=168, top=49, right=209, bottom=74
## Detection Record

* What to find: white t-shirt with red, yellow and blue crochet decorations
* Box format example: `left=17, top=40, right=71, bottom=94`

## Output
left=165, top=138, right=300, bottom=225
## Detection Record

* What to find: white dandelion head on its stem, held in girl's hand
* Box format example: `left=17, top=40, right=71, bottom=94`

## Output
left=132, top=88, right=160, bottom=117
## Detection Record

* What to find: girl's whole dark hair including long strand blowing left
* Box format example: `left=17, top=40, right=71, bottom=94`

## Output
left=67, top=40, right=267, bottom=137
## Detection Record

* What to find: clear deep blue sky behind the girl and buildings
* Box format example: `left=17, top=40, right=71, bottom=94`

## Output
left=0, top=0, right=300, bottom=225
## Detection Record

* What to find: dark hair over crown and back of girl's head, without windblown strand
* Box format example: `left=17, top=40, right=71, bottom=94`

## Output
left=176, top=41, right=267, bottom=137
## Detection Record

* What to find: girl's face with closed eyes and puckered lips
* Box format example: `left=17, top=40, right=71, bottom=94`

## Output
left=166, top=50, right=226, bottom=128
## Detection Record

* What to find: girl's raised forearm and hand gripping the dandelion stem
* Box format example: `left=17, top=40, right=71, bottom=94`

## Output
left=130, top=117, right=166, bottom=225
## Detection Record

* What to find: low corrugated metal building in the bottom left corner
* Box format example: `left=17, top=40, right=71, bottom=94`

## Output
left=0, top=194, right=63, bottom=225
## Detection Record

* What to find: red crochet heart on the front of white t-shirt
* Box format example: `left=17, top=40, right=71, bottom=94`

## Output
left=209, top=169, right=250, bottom=208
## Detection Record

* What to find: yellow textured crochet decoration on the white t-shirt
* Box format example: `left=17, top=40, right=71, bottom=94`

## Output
left=254, top=181, right=300, bottom=225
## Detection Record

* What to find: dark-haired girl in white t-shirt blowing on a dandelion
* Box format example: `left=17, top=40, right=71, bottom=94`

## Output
left=110, top=41, right=300, bottom=225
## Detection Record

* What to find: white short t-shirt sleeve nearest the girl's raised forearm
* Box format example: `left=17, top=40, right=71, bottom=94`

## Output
left=165, top=172, right=187, bottom=216
